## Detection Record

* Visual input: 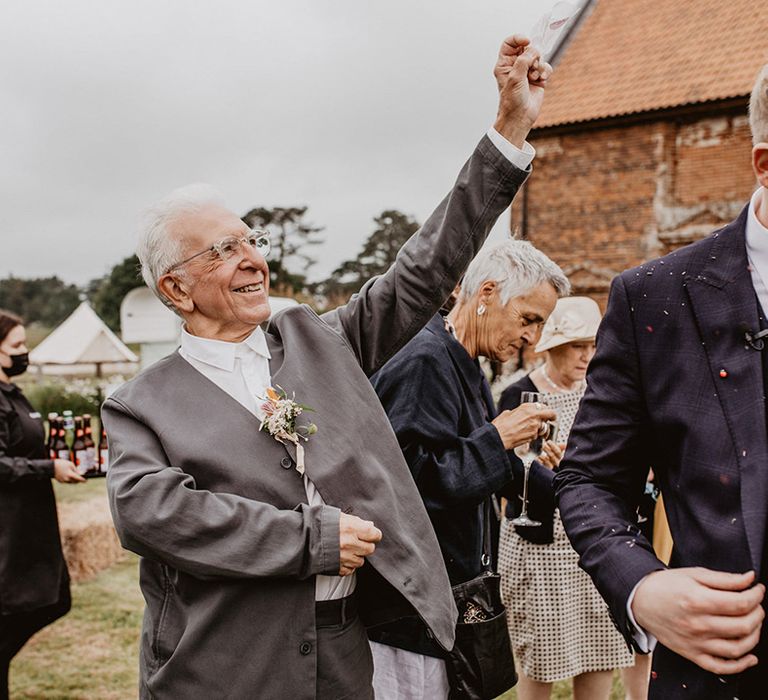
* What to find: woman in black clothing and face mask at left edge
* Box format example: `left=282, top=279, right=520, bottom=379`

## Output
left=0, top=311, right=85, bottom=700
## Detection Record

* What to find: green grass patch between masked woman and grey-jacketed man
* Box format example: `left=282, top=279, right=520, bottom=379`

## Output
left=11, top=555, right=144, bottom=700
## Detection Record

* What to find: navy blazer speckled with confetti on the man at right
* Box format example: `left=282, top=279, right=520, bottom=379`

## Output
left=555, top=209, right=768, bottom=700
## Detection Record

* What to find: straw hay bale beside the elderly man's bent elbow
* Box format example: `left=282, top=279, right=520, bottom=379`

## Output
left=58, top=496, right=125, bottom=581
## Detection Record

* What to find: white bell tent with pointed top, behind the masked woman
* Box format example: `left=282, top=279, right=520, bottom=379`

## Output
left=29, top=301, right=139, bottom=377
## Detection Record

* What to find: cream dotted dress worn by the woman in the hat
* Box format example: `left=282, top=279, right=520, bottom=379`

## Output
left=499, top=391, right=634, bottom=683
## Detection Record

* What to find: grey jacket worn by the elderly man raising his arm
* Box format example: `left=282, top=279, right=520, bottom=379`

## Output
left=103, top=137, right=526, bottom=699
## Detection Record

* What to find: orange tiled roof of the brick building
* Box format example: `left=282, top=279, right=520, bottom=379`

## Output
left=536, top=0, right=768, bottom=128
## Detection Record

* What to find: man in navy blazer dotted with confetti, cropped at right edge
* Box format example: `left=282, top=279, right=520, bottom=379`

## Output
left=555, top=65, right=768, bottom=700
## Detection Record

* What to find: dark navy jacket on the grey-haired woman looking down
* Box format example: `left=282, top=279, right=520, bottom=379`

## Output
left=369, top=316, right=552, bottom=656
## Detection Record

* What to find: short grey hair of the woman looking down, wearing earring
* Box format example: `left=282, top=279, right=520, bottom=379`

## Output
left=460, top=239, right=571, bottom=306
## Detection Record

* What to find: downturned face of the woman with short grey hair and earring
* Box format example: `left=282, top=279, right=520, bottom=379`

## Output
left=478, top=282, right=557, bottom=362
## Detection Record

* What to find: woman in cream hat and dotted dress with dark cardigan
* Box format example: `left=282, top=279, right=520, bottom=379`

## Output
left=499, top=297, right=633, bottom=700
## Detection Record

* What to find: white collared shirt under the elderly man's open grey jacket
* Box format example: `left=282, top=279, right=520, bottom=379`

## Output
left=179, top=327, right=356, bottom=600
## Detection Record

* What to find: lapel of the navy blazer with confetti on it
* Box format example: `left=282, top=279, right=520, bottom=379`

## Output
left=686, top=209, right=768, bottom=573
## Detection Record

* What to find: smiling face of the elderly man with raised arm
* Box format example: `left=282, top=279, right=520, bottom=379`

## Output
left=158, top=204, right=270, bottom=342
